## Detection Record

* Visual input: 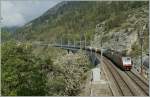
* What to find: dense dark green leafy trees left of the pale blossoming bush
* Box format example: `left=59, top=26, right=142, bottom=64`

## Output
left=1, top=41, right=46, bottom=96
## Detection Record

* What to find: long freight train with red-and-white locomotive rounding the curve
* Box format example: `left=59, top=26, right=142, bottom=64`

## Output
left=56, top=45, right=132, bottom=71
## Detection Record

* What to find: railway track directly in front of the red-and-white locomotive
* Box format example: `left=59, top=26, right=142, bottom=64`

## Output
left=126, top=71, right=149, bottom=96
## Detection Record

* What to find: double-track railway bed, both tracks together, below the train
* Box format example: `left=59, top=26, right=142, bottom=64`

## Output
left=103, top=57, right=149, bottom=96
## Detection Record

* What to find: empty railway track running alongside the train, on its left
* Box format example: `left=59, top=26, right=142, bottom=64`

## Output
left=103, top=57, right=136, bottom=96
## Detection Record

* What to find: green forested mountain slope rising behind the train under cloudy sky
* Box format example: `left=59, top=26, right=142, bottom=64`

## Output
left=14, top=1, right=148, bottom=42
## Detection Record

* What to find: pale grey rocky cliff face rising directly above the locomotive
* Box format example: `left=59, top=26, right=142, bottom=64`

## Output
left=92, top=6, right=149, bottom=66
